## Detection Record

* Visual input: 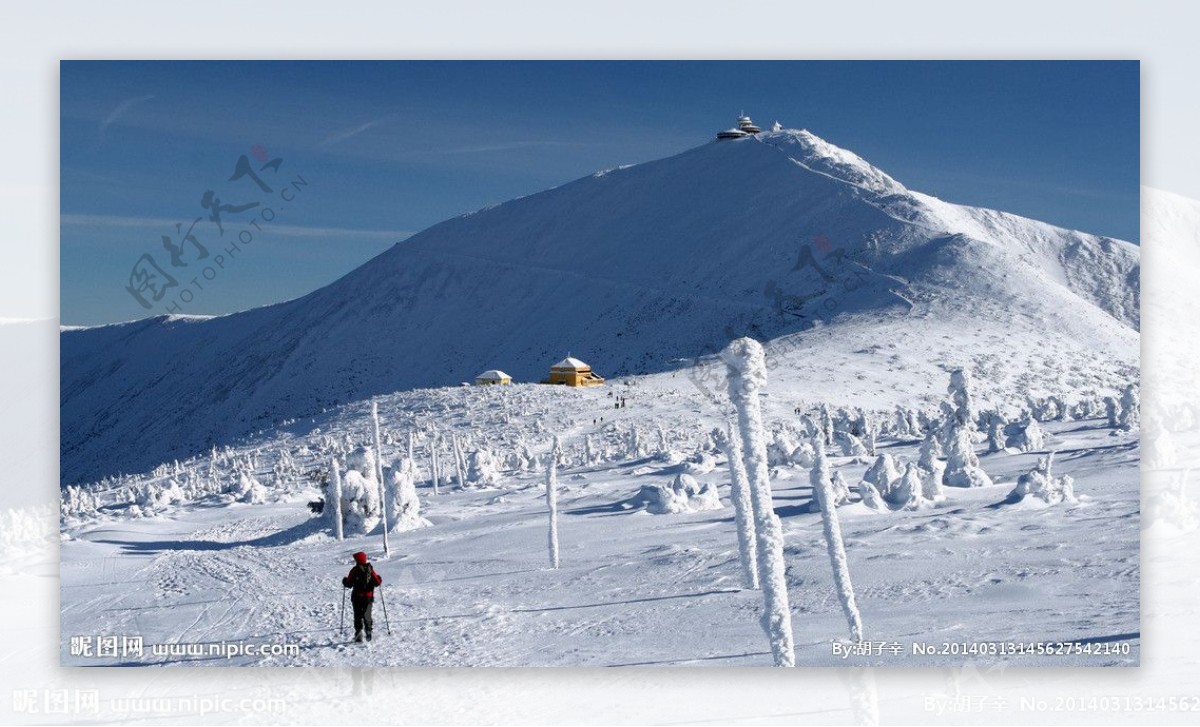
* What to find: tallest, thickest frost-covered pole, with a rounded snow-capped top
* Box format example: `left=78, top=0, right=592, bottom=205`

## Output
left=721, top=338, right=796, bottom=667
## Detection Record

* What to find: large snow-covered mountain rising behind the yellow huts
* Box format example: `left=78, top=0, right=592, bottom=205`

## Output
left=61, top=131, right=1140, bottom=482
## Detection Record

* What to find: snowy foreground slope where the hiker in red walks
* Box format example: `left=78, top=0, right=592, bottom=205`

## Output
left=61, top=374, right=1140, bottom=666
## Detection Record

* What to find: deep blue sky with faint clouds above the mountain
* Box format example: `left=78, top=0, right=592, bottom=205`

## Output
left=60, top=61, right=1140, bottom=325
